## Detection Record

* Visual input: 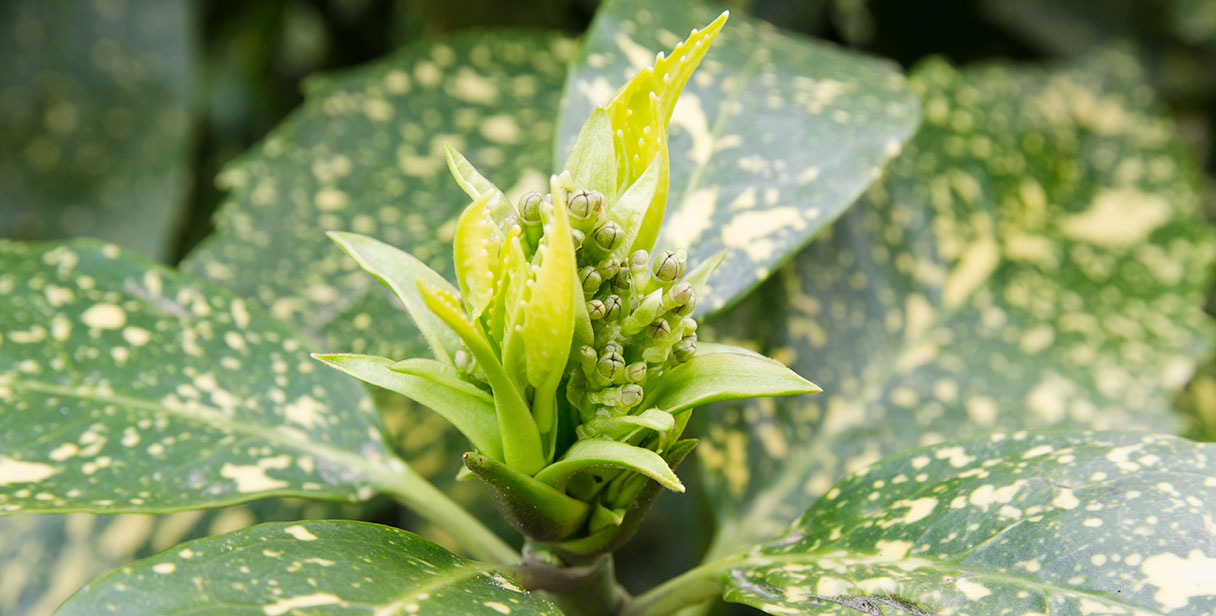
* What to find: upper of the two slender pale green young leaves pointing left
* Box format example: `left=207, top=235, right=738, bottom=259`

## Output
left=328, top=231, right=461, bottom=363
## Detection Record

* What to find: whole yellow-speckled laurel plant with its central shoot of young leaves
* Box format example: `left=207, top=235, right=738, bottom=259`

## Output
left=0, top=0, right=1216, bottom=616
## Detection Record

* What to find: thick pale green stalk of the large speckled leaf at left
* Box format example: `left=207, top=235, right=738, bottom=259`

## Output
left=377, top=464, right=519, bottom=565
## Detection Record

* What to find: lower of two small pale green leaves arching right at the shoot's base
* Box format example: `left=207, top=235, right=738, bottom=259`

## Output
left=536, top=439, right=683, bottom=492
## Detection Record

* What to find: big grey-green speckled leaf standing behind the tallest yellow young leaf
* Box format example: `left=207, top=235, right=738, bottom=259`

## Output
left=556, top=0, right=919, bottom=312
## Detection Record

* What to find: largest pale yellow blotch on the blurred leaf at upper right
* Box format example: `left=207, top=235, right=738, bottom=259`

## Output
left=1059, top=188, right=1173, bottom=248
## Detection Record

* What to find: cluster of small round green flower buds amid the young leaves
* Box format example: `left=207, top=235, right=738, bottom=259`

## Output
left=518, top=190, right=697, bottom=436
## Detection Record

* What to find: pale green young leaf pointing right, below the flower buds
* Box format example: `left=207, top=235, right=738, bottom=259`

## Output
left=641, top=344, right=822, bottom=413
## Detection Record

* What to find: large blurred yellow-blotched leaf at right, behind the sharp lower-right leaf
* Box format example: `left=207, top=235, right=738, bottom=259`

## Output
left=698, top=50, right=1214, bottom=549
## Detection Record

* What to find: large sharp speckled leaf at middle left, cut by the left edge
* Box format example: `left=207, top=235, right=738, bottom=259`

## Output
left=0, top=242, right=402, bottom=513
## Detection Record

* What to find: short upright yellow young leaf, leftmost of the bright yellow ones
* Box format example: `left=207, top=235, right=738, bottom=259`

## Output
left=452, top=194, right=503, bottom=320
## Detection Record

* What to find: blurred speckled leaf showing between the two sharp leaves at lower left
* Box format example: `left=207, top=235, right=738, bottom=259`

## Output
left=0, top=498, right=367, bottom=616
